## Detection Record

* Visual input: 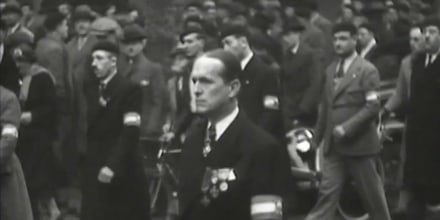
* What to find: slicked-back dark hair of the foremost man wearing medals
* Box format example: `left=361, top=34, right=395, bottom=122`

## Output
left=203, top=49, right=241, bottom=82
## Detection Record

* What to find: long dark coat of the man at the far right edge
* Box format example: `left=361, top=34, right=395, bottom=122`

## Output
left=404, top=53, right=440, bottom=187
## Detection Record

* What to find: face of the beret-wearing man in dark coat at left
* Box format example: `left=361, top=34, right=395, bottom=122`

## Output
left=92, top=50, right=116, bottom=79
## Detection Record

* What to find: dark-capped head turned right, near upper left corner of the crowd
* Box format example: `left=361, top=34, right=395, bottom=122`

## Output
left=44, top=12, right=69, bottom=39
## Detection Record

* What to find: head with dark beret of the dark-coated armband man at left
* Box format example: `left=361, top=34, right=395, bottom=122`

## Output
left=92, top=41, right=119, bottom=80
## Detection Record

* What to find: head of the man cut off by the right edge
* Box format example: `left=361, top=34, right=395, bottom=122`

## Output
left=423, top=17, right=440, bottom=53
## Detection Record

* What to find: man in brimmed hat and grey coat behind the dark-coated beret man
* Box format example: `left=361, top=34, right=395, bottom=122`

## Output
left=119, top=24, right=166, bottom=137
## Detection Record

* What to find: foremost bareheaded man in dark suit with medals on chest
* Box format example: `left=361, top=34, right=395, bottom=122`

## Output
left=180, top=50, right=289, bottom=220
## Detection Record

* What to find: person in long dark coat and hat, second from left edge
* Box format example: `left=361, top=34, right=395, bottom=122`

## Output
left=13, top=44, right=57, bottom=220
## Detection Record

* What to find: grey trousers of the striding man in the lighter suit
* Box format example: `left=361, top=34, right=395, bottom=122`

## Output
left=306, top=152, right=391, bottom=220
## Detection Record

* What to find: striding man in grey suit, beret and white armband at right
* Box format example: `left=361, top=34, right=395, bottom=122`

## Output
left=306, top=23, right=390, bottom=220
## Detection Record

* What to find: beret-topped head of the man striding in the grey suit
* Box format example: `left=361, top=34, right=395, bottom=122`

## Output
left=332, top=22, right=357, bottom=57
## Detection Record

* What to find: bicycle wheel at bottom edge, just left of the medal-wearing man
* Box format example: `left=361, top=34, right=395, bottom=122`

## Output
left=149, top=178, right=178, bottom=220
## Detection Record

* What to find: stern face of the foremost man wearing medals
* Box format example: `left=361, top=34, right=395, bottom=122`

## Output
left=190, top=57, right=234, bottom=115
